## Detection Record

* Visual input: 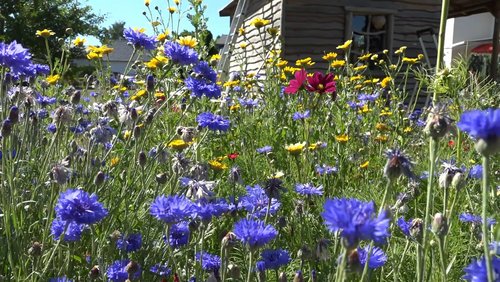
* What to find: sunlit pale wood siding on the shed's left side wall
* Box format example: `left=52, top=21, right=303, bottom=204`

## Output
left=229, top=0, right=283, bottom=73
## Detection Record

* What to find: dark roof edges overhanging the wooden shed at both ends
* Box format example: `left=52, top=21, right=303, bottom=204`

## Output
left=219, top=0, right=500, bottom=18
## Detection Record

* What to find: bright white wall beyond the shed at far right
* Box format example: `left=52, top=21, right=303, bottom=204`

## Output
left=444, top=13, right=495, bottom=66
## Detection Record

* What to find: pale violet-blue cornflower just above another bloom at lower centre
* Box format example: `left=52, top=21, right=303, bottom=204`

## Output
left=238, top=185, right=281, bottom=218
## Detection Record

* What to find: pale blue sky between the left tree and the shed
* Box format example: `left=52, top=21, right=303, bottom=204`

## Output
left=81, top=0, right=230, bottom=45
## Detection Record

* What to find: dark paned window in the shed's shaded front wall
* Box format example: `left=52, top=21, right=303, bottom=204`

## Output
left=345, top=7, right=396, bottom=56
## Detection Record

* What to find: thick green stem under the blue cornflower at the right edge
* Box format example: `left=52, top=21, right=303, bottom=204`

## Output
left=482, top=156, right=494, bottom=282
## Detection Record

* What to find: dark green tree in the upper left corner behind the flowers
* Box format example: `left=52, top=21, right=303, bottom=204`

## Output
left=0, top=0, right=104, bottom=59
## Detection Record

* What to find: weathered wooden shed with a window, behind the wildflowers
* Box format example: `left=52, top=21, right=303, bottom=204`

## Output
left=219, top=0, right=500, bottom=79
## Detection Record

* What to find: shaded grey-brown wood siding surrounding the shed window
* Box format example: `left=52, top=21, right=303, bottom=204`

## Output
left=282, top=0, right=441, bottom=69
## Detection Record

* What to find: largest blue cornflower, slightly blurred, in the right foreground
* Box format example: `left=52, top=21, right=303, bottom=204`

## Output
left=322, top=198, right=390, bottom=246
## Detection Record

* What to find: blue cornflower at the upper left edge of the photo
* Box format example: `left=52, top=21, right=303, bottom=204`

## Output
left=0, top=40, right=31, bottom=77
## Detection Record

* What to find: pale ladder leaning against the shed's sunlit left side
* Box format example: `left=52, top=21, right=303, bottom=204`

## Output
left=217, top=0, right=250, bottom=81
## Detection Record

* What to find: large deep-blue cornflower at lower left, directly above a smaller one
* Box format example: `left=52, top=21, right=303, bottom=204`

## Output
left=55, top=189, right=108, bottom=224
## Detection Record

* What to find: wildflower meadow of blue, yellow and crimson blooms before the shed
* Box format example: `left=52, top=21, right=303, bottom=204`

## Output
left=0, top=0, right=500, bottom=282
